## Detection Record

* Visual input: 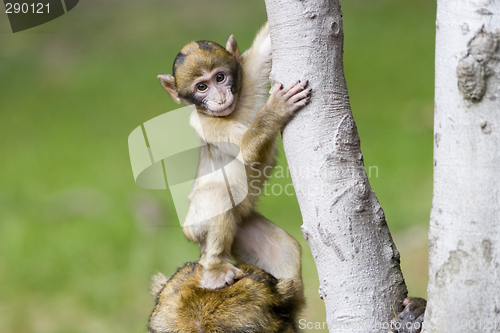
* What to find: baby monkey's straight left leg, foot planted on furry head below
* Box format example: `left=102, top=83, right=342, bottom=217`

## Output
left=183, top=183, right=243, bottom=289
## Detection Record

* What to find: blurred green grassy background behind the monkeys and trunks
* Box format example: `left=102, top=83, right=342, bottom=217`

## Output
left=0, top=0, right=435, bottom=333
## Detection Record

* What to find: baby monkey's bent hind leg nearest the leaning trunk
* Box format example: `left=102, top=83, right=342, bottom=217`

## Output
left=232, top=212, right=301, bottom=280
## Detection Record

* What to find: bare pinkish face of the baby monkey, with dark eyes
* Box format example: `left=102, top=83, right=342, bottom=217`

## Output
left=193, top=68, right=236, bottom=117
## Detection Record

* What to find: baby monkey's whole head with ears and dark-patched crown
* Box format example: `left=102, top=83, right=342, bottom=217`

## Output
left=158, top=35, right=242, bottom=117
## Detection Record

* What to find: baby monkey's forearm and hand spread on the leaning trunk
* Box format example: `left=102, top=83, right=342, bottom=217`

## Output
left=239, top=81, right=311, bottom=165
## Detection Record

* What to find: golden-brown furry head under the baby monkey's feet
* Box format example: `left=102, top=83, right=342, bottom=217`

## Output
left=148, top=263, right=304, bottom=333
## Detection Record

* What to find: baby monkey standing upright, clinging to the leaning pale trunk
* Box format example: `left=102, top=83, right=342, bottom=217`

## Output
left=158, top=25, right=311, bottom=290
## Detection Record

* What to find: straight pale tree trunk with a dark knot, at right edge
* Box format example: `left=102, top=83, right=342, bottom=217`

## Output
left=424, top=0, right=500, bottom=332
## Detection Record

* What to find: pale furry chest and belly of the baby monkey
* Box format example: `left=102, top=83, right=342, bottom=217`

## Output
left=190, top=111, right=276, bottom=217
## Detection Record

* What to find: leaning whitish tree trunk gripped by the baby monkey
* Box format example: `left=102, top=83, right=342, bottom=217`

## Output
left=266, top=0, right=407, bottom=333
